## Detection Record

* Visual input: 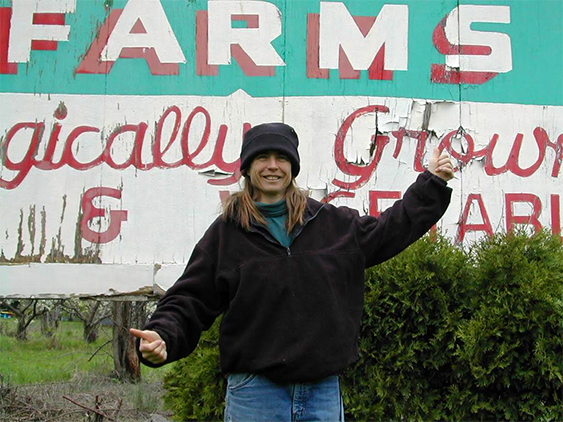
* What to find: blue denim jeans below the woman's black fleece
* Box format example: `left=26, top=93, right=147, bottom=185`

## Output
left=225, top=374, right=344, bottom=422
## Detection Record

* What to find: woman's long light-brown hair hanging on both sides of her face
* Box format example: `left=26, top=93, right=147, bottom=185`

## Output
left=223, top=176, right=307, bottom=234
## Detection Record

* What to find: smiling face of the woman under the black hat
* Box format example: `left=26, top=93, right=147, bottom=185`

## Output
left=249, top=150, right=291, bottom=204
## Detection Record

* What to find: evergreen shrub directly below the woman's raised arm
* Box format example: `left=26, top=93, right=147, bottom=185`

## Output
left=342, top=235, right=474, bottom=421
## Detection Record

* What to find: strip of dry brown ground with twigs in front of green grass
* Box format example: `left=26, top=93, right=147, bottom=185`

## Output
left=0, top=377, right=171, bottom=422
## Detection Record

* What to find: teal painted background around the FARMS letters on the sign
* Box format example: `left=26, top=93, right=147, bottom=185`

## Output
left=0, top=0, right=563, bottom=105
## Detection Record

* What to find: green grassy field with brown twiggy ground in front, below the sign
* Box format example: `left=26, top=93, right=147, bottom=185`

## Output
left=0, top=319, right=173, bottom=421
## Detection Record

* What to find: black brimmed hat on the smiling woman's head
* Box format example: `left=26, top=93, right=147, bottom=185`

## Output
left=240, top=123, right=301, bottom=177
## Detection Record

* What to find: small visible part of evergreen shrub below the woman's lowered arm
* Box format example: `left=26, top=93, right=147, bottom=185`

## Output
left=164, top=318, right=227, bottom=421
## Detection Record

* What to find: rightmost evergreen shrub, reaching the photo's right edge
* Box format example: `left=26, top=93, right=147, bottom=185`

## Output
left=457, top=232, right=563, bottom=421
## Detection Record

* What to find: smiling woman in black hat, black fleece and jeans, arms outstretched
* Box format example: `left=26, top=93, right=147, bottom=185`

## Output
left=131, top=123, right=453, bottom=421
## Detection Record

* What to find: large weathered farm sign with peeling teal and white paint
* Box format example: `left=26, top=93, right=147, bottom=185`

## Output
left=0, top=0, right=563, bottom=297
